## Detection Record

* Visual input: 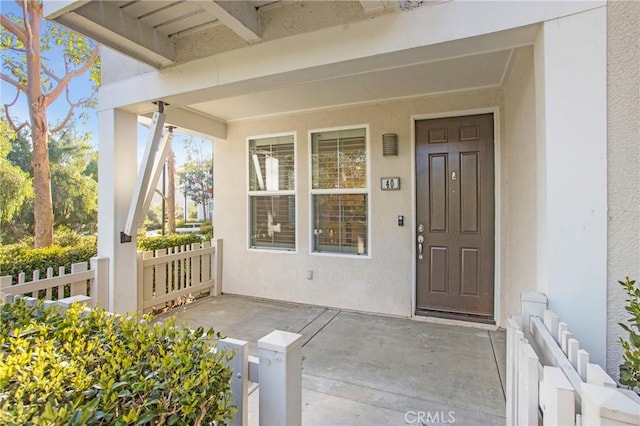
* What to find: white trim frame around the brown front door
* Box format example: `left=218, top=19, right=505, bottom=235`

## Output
left=410, top=106, right=502, bottom=326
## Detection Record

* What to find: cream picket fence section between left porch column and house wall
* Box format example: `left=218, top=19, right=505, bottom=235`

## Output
left=137, top=240, right=222, bottom=312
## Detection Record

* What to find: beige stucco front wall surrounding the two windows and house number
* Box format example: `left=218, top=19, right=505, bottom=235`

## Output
left=214, top=88, right=502, bottom=316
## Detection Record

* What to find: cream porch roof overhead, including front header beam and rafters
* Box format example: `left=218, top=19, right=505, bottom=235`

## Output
left=45, top=0, right=564, bottom=137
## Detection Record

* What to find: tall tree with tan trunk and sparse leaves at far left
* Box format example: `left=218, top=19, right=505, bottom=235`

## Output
left=0, top=0, right=100, bottom=247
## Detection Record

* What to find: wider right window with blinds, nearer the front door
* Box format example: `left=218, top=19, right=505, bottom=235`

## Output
left=311, top=128, right=369, bottom=255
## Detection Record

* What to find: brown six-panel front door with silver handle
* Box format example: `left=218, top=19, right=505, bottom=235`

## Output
left=415, top=114, right=494, bottom=320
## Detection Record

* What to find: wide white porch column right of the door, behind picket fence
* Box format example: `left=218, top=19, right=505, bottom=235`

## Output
left=534, top=7, right=607, bottom=365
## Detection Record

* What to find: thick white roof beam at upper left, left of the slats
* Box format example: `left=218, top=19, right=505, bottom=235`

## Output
left=72, top=1, right=176, bottom=66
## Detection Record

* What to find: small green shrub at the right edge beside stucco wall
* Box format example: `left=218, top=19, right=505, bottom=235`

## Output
left=618, top=277, right=640, bottom=391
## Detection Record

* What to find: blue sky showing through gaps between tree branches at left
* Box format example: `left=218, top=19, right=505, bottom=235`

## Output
left=0, top=0, right=213, bottom=164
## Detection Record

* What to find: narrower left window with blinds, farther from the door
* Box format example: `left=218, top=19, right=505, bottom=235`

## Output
left=248, top=134, right=296, bottom=250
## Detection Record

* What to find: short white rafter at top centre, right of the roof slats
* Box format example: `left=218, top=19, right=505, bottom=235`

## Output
left=200, top=0, right=262, bottom=41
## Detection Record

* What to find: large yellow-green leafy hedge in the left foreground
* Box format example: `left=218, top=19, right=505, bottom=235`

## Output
left=0, top=301, right=235, bottom=425
